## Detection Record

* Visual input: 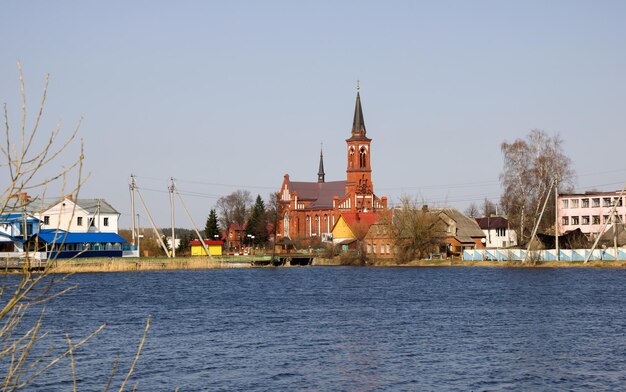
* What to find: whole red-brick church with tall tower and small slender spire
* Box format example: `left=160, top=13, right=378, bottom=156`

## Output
left=277, top=90, right=387, bottom=240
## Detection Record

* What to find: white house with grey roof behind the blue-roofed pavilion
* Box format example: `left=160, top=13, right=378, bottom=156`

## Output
left=36, top=196, right=120, bottom=233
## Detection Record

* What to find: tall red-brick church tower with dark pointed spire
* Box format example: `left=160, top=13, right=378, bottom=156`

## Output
left=346, top=84, right=374, bottom=202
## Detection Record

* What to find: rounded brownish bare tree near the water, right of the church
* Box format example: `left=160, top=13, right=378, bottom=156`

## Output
left=387, top=196, right=445, bottom=261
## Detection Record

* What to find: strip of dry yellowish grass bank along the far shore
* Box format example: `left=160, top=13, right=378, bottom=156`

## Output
left=30, top=257, right=626, bottom=274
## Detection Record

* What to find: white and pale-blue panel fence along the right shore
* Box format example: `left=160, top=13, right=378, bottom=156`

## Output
left=463, top=248, right=626, bottom=261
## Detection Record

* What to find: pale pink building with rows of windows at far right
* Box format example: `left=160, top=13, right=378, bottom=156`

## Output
left=557, top=192, right=626, bottom=238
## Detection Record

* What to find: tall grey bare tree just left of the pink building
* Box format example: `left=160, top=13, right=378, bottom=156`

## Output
left=500, top=129, right=575, bottom=243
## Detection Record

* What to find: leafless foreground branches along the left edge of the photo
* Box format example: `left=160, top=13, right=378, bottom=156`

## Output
left=0, top=63, right=149, bottom=390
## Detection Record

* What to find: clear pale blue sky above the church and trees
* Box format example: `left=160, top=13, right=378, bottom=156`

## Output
left=0, top=0, right=626, bottom=228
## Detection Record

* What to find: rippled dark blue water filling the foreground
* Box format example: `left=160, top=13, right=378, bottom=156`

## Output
left=11, top=267, right=626, bottom=391
